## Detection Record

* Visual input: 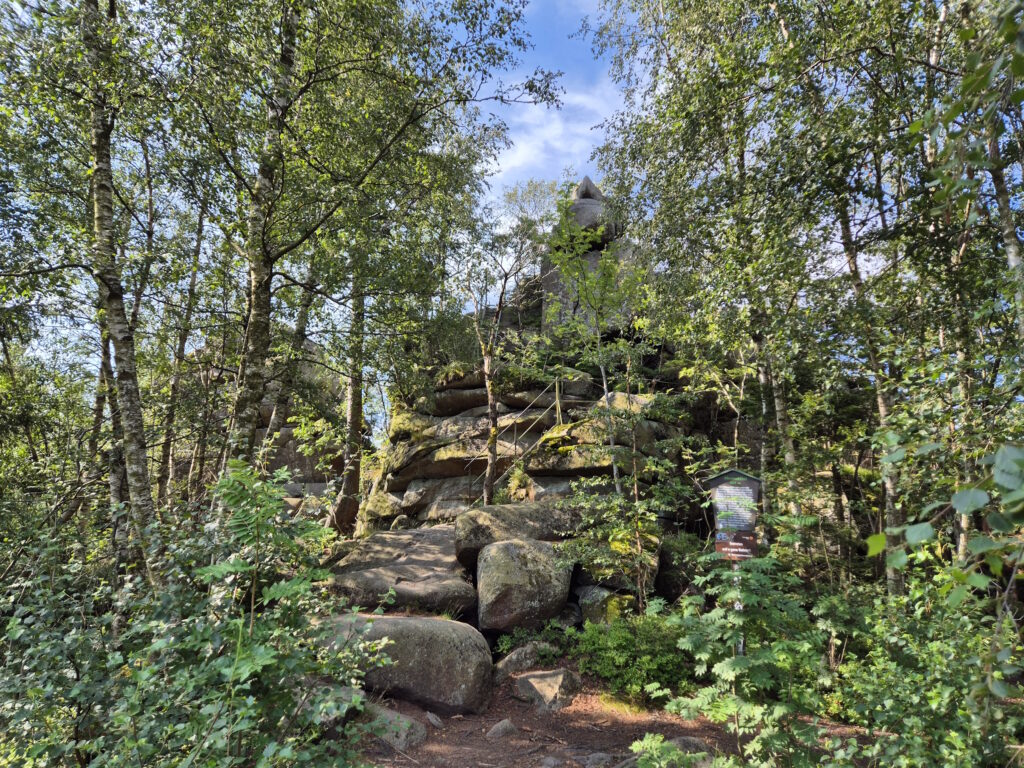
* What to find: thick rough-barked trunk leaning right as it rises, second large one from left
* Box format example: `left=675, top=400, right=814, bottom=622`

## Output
left=231, top=2, right=298, bottom=458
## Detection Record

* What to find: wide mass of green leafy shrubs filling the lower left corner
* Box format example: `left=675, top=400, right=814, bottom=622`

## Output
left=0, top=465, right=380, bottom=768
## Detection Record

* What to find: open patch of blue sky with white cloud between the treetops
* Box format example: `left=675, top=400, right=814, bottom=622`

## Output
left=490, top=0, right=620, bottom=194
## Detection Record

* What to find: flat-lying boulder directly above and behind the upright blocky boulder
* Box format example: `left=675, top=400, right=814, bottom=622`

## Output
left=455, top=504, right=579, bottom=570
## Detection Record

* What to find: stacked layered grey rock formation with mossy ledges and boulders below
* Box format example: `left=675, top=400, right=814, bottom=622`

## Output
left=315, top=178, right=724, bottom=713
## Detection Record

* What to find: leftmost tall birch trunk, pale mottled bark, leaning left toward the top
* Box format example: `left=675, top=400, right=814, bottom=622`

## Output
left=83, top=0, right=154, bottom=552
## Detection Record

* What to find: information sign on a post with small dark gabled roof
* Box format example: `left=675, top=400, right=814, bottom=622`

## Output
left=705, top=469, right=761, bottom=656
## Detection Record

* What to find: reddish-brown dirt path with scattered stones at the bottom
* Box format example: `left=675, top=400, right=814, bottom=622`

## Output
left=364, top=680, right=729, bottom=768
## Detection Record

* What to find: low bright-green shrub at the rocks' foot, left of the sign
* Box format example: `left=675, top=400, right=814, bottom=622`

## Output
left=571, top=614, right=693, bottom=701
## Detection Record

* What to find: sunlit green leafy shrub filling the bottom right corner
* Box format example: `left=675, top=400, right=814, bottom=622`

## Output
left=828, top=580, right=1024, bottom=768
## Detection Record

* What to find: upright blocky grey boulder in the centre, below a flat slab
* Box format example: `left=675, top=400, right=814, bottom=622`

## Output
left=476, top=539, right=571, bottom=632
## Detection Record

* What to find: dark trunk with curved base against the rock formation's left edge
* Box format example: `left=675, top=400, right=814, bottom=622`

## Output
left=331, top=276, right=367, bottom=532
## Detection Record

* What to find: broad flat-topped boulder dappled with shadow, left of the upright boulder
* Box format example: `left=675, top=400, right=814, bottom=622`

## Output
left=331, top=524, right=476, bottom=615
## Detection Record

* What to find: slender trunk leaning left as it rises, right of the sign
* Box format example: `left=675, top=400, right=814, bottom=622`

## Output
left=839, top=201, right=904, bottom=595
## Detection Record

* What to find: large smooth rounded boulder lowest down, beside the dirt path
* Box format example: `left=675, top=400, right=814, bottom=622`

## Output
left=356, top=616, right=493, bottom=715
